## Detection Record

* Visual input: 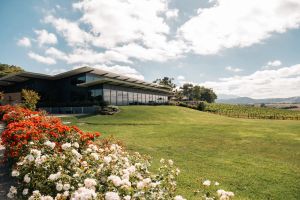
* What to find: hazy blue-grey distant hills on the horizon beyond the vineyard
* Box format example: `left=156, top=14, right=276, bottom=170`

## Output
left=216, top=96, right=300, bottom=104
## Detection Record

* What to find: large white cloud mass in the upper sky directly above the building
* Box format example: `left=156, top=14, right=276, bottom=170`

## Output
left=44, top=0, right=186, bottom=64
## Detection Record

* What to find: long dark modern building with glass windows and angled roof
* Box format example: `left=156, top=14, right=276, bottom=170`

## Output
left=0, top=67, right=171, bottom=111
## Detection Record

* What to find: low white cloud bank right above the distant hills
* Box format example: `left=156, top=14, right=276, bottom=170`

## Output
left=200, top=64, right=300, bottom=98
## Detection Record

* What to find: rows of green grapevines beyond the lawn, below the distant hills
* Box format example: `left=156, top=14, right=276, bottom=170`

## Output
left=205, top=103, right=300, bottom=120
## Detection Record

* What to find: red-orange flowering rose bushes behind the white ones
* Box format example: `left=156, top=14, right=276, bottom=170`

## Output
left=0, top=106, right=100, bottom=158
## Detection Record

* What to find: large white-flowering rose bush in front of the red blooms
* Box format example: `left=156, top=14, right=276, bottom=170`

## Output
left=9, top=141, right=179, bottom=200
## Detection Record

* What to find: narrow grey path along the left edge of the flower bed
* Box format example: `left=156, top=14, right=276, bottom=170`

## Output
left=0, top=122, right=13, bottom=200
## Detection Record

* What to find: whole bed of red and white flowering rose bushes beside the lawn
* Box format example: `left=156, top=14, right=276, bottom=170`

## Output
left=0, top=106, right=183, bottom=200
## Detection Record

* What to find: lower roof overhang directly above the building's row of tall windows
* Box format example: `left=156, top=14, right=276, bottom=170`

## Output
left=77, top=77, right=172, bottom=94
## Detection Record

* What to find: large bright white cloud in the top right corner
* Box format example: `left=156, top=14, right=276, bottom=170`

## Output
left=178, top=0, right=300, bottom=55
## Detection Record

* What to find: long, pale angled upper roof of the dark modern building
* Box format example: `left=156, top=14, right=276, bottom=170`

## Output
left=0, top=67, right=171, bottom=92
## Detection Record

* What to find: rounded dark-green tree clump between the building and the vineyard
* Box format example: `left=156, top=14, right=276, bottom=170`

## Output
left=180, top=83, right=217, bottom=103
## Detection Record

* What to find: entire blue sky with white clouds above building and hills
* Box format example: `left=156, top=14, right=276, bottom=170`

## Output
left=0, top=0, right=300, bottom=98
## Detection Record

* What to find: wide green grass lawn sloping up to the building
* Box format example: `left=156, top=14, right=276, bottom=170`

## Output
left=64, top=106, right=300, bottom=200
